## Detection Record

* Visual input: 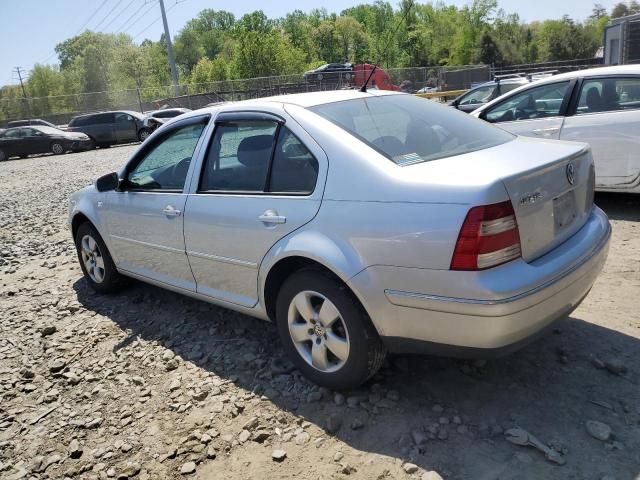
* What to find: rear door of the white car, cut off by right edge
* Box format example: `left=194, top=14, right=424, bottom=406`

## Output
left=560, top=76, right=640, bottom=188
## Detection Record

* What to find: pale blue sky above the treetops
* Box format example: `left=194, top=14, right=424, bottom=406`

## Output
left=0, top=0, right=616, bottom=85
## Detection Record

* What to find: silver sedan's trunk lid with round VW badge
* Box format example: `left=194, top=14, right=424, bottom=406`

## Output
left=401, top=137, right=594, bottom=261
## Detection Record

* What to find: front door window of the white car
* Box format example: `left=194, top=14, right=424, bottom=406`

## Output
left=484, top=81, right=569, bottom=123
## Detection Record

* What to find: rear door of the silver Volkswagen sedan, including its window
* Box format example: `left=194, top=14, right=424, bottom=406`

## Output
left=184, top=112, right=327, bottom=307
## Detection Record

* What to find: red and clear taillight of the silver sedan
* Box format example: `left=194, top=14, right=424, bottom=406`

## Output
left=451, top=202, right=521, bottom=270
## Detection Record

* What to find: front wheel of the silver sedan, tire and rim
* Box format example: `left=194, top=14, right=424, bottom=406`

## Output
left=75, top=222, right=127, bottom=293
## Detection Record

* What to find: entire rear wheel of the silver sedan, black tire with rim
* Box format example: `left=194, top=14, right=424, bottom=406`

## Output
left=276, top=270, right=386, bottom=390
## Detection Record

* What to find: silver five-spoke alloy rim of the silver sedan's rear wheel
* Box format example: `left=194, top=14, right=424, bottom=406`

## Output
left=288, top=290, right=349, bottom=373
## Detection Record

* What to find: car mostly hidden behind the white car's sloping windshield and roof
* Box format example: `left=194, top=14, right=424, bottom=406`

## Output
left=449, top=72, right=555, bottom=113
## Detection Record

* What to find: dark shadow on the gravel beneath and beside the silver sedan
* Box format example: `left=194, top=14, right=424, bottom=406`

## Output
left=73, top=279, right=640, bottom=479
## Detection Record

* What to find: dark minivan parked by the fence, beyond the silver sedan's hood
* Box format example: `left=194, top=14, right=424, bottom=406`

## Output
left=67, top=110, right=151, bottom=147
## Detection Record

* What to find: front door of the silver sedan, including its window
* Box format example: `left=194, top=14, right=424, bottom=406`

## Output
left=101, top=115, right=209, bottom=291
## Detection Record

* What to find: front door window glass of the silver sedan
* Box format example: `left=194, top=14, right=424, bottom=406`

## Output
left=127, top=121, right=206, bottom=191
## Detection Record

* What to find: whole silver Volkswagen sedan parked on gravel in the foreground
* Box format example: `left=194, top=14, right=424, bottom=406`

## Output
left=69, top=91, right=610, bottom=389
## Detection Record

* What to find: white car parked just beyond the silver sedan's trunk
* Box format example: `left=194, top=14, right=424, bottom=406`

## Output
left=471, top=65, right=640, bottom=193
